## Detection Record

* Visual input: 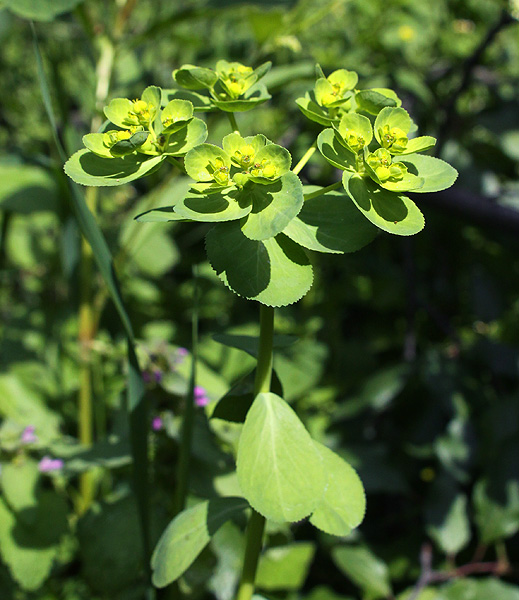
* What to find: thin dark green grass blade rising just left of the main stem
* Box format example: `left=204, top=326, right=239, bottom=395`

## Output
left=175, top=265, right=198, bottom=514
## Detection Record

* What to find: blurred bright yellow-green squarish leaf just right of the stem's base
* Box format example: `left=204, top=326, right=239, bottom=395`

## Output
left=256, top=542, right=315, bottom=591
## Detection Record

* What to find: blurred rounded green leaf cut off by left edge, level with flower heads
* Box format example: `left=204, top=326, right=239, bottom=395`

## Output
left=0, top=164, right=58, bottom=214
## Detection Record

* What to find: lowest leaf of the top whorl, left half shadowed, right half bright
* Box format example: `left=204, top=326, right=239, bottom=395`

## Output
left=206, top=221, right=313, bottom=306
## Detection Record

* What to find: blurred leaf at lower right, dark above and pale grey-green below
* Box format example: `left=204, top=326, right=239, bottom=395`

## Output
left=425, top=476, right=470, bottom=555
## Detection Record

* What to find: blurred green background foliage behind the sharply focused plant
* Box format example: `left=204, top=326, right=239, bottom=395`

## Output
left=0, top=0, right=519, bottom=600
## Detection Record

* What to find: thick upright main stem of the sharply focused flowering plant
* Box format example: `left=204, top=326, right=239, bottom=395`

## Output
left=236, top=304, right=274, bottom=600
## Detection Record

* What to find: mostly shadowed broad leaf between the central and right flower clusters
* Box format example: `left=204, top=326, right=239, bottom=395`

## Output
left=283, top=190, right=378, bottom=254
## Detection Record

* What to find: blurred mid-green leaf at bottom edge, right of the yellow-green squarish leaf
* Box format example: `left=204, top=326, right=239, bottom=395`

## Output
left=332, top=546, right=392, bottom=600
